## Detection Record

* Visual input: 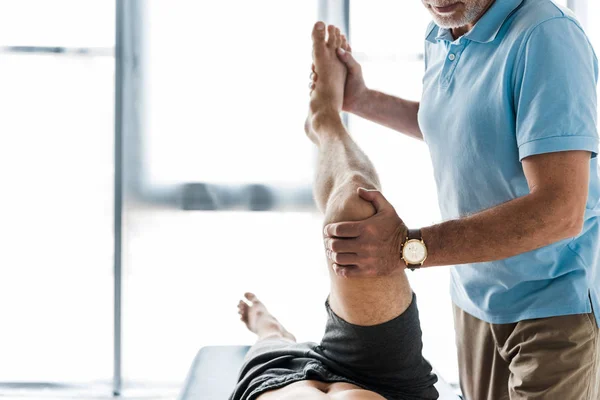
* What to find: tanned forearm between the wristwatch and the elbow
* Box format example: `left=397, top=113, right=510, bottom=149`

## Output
left=422, top=193, right=583, bottom=267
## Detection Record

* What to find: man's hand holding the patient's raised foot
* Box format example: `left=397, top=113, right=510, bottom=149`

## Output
left=309, top=28, right=369, bottom=113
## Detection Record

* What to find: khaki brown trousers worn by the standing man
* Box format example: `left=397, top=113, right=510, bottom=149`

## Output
left=454, top=306, right=600, bottom=400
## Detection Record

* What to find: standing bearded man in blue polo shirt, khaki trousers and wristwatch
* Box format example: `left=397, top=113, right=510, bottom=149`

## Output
left=313, top=0, right=600, bottom=400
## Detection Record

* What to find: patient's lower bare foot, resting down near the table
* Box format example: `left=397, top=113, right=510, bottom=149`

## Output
left=238, top=292, right=296, bottom=342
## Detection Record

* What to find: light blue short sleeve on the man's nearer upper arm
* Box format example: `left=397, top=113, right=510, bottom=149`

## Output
left=515, top=17, right=598, bottom=160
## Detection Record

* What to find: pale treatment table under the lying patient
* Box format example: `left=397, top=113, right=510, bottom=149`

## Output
left=179, top=346, right=460, bottom=400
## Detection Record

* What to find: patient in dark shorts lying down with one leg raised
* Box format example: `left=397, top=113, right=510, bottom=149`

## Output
left=230, top=22, right=438, bottom=400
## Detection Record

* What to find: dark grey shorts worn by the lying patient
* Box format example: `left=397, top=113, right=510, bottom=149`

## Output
left=230, top=295, right=438, bottom=400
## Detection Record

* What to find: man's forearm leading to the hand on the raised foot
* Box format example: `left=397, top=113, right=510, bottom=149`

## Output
left=350, top=89, right=423, bottom=140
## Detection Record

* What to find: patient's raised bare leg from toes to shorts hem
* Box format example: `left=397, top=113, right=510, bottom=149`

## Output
left=306, top=23, right=412, bottom=325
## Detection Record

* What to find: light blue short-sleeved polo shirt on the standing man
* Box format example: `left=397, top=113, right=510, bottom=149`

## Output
left=419, top=0, right=600, bottom=324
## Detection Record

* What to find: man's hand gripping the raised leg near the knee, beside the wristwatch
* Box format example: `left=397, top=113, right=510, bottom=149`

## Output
left=324, top=188, right=408, bottom=278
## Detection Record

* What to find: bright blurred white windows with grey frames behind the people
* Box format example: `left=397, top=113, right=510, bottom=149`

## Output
left=0, top=0, right=600, bottom=399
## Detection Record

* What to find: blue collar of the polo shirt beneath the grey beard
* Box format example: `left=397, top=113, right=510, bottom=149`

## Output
left=426, top=0, right=524, bottom=43
